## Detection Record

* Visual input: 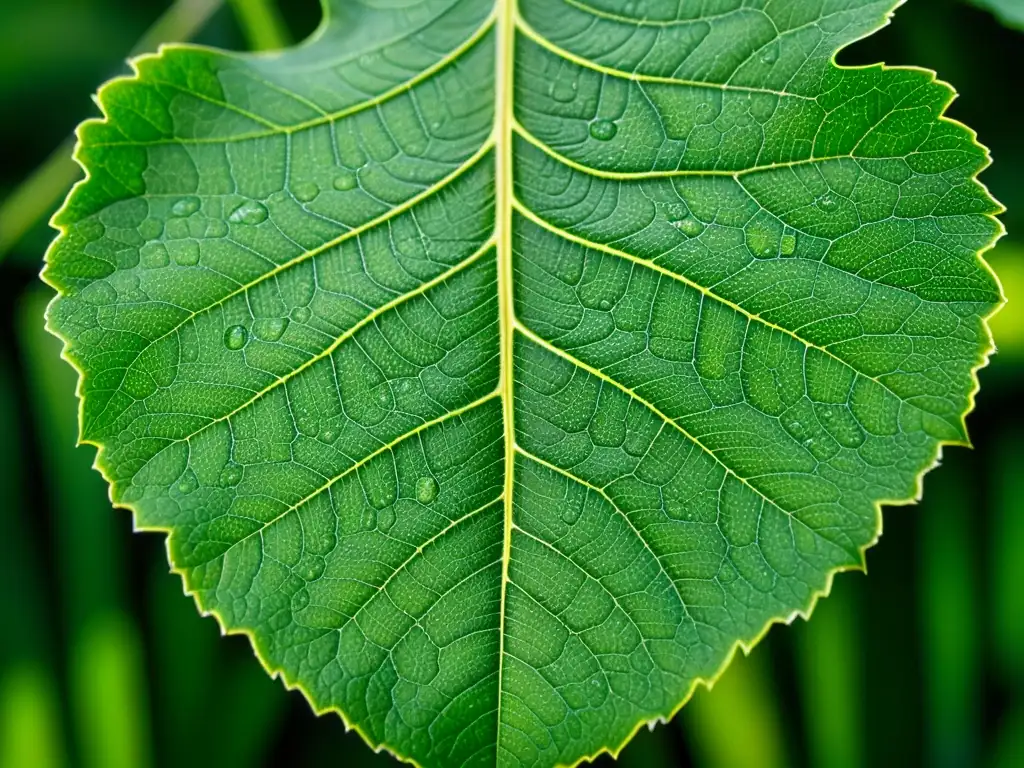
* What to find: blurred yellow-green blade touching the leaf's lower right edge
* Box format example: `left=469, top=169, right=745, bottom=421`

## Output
left=683, top=647, right=792, bottom=768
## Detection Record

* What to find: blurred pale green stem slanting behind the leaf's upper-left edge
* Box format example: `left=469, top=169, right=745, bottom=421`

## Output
left=0, top=0, right=223, bottom=261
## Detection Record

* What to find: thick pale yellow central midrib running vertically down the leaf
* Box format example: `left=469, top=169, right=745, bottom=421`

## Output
left=494, top=0, right=517, bottom=762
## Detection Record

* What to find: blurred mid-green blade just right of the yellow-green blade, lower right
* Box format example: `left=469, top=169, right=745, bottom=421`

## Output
left=794, top=574, right=864, bottom=768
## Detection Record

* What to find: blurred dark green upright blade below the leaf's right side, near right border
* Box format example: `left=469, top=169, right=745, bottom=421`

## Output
left=921, top=456, right=981, bottom=768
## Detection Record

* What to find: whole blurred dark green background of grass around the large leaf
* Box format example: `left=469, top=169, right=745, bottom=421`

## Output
left=0, top=0, right=1024, bottom=768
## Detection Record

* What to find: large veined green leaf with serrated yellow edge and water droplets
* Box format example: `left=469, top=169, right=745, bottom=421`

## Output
left=45, top=0, right=1000, bottom=766
